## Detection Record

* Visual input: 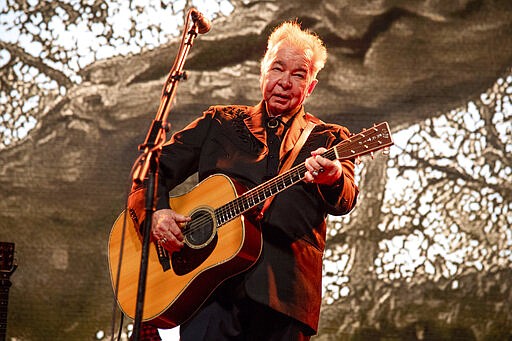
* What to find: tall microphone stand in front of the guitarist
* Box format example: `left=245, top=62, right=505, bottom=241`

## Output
left=132, top=8, right=202, bottom=341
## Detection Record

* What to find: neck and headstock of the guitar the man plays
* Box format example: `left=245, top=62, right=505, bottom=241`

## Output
left=215, top=122, right=393, bottom=226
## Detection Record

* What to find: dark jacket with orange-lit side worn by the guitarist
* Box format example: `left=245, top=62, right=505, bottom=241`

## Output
left=157, top=103, right=358, bottom=331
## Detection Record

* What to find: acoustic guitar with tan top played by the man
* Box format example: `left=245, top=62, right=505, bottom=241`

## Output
left=108, top=122, right=393, bottom=328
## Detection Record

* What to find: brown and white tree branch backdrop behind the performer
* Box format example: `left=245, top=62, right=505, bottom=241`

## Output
left=0, top=0, right=512, bottom=340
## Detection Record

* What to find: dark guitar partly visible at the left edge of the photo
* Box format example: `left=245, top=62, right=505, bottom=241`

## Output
left=0, top=242, right=17, bottom=341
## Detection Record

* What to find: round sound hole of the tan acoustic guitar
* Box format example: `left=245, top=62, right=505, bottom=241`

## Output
left=185, top=210, right=216, bottom=248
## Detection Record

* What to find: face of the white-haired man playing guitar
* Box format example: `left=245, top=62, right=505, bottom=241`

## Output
left=260, top=44, right=317, bottom=116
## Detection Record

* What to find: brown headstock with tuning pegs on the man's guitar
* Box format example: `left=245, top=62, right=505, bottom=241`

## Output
left=336, top=122, right=393, bottom=159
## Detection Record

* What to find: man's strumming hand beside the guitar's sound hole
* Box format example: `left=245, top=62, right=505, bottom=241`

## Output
left=151, top=209, right=191, bottom=252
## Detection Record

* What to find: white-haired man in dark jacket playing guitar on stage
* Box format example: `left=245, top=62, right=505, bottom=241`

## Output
left=148, top=22, right=358, bottom=341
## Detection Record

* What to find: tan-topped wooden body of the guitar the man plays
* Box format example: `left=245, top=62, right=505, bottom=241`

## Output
left=108, top=174, right=262, bottom=328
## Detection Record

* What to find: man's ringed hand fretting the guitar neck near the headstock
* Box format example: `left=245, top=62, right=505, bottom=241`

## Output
left=304, top=148, right=343, bottom=185
